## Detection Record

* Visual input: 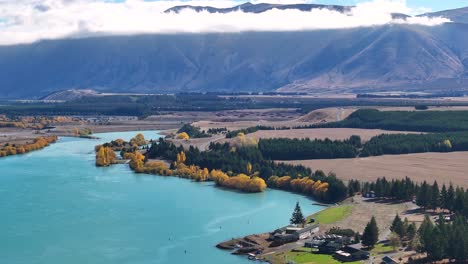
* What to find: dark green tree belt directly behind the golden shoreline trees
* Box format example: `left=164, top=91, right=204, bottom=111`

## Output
left=146, top=138, right=348, bottom=202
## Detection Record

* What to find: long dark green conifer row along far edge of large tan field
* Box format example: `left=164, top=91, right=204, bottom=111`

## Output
left=258, top=132, right=468, bottom=160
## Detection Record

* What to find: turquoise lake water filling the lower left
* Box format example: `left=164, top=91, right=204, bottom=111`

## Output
left=0, top=131, right=321, bottom=264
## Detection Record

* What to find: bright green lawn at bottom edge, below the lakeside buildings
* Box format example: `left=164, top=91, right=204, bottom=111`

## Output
left=271, top=252, right=361, bottom=264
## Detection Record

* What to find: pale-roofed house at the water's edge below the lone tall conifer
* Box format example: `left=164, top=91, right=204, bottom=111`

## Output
left=270, top=224, right=319, bottom=244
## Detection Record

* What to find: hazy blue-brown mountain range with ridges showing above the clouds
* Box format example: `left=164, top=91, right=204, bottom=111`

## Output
left=0, top=4, right=468, bottom=98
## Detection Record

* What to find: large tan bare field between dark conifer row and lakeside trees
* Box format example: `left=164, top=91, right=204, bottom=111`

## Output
left=287, top=152, right=468, bottom=188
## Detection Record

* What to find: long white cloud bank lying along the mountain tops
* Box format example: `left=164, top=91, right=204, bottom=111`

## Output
left=0, top=0, right=450, bottom=45
